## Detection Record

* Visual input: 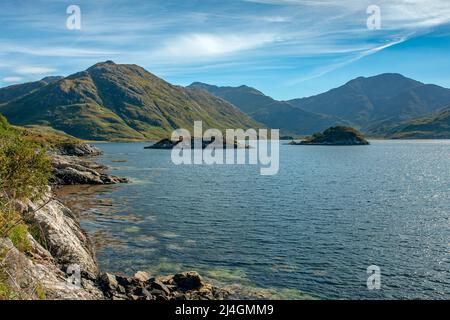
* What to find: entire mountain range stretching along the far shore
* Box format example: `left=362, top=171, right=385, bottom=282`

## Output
left=0, top=68, right=450, bottom=140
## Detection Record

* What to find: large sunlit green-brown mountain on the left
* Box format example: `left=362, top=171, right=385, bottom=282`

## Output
left=0, top=61, right=261, bottom=140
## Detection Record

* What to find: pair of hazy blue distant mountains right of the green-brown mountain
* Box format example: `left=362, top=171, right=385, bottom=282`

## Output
left=190, top=73, right=450, bottom=138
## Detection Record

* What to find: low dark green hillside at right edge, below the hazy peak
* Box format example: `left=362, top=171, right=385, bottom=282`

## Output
left=376, top=107, right=450, bottom=139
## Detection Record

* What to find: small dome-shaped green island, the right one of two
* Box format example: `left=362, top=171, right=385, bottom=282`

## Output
left=290, top=126, right=369, bottom=146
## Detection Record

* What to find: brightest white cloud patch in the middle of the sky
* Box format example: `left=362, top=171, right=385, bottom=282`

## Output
left=154, top=33, right=277, bottom=60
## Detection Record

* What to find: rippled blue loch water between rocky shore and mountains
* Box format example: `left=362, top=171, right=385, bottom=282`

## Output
left=61, top=141, right=450, bottom=299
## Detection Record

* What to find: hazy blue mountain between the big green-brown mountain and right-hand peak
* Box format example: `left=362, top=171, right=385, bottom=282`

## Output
left=189, top=82, right=347, bottom=135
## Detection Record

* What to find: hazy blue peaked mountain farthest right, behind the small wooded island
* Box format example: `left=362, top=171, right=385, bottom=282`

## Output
left=288, top=73, right=450, bottom=132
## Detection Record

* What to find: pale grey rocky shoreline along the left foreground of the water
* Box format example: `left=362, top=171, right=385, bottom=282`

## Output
left=0, top=142, right=253, bottom=301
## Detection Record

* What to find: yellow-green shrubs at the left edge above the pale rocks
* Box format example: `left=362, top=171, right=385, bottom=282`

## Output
left=0, top=115, right=52, bottom=300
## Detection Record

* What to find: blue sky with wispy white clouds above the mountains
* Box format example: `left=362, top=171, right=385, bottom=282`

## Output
left=0, top=0, right=450, bottom=99
